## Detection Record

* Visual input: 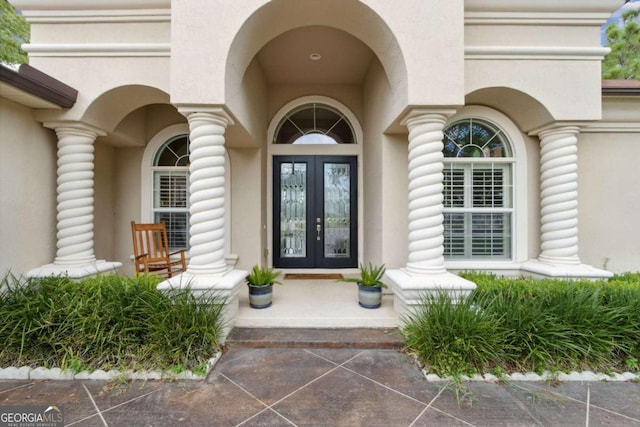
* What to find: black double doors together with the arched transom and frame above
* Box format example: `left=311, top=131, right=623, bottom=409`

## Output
left=268, top=96, right=362, bottom=269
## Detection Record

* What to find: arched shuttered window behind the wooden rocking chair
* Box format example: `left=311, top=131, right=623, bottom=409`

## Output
left=152, top=135, right=189, bottom=250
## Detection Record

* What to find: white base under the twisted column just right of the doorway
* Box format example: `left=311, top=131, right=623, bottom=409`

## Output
left=386, top=269, right=476, bottom=323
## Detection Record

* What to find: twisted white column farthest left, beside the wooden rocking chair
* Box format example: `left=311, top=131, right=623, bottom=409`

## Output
left=54, top=123, right=101, bottom=266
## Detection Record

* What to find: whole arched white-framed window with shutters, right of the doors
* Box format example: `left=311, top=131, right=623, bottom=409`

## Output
left=443, top=118, right=514, bottom=260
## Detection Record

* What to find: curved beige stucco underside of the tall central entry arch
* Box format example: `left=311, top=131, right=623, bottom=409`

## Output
left=225, top=0, right=408, bottom=140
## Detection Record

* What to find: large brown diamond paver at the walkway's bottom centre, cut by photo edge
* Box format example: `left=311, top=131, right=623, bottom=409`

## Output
left=273, top=368, right=425, bottom=427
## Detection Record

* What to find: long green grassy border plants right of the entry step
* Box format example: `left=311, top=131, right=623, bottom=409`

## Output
left=404, top=273, right=640, bottom=375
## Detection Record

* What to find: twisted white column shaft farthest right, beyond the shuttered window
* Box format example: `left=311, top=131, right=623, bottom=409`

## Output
left=538, top=126, right=580, bottom=265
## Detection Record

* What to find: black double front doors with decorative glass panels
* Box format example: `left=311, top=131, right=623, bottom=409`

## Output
left=273, top=156, right=358, bottom=268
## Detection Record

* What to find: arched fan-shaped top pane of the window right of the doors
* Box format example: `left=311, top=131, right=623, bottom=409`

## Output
left=443, top=119, right=512, bottom=158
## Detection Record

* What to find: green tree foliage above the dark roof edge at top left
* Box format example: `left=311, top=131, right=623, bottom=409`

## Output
left=0, top=0, right=30, bottom=64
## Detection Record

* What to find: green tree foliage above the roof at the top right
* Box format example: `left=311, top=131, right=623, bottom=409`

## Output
left=602, top=9, right=640, bottom=80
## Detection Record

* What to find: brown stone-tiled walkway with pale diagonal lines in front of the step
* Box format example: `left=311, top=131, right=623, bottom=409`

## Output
left=0, top=332, right=640, bottom=426
